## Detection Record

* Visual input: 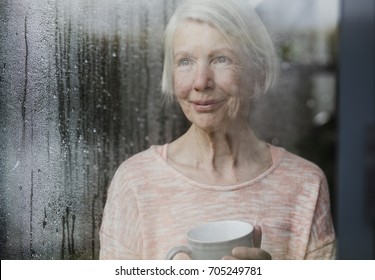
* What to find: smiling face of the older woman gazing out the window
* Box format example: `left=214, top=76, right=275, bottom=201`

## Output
left=173, top=21, right=248, bottom=132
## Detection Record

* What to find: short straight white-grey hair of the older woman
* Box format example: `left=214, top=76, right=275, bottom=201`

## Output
left=162, top=0, right=278, bottom=99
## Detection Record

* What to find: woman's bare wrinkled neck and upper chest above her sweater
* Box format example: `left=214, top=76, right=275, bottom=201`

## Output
left=169, top=123, right=272, bottom=185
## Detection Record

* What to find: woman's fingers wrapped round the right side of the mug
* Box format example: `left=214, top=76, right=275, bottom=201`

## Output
left=223, top=226, right=272, bottom=260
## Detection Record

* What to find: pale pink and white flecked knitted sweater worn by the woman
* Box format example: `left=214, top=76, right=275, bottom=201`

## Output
left=100, top=145, right=336, bottom=259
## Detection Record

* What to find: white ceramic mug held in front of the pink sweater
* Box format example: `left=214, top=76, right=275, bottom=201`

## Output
left=166, top=220, right=254, bottom=260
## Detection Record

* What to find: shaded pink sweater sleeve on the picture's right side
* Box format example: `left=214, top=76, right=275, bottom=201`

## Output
left=305, top=178, right=336, bottom=259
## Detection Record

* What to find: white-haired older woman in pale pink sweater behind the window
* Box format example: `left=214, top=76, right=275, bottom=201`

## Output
left=100, top=0, right=335, bottom=259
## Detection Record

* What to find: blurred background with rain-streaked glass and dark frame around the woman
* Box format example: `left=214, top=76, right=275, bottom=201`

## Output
left=0, top=0, right=375, bottom=259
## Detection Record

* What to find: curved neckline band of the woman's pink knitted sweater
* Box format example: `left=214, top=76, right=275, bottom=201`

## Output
left=150, top=143, right=285, bottom=191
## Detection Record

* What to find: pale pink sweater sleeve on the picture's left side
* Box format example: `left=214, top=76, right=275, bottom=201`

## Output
left=99, top=164, right=143, bottom=260
